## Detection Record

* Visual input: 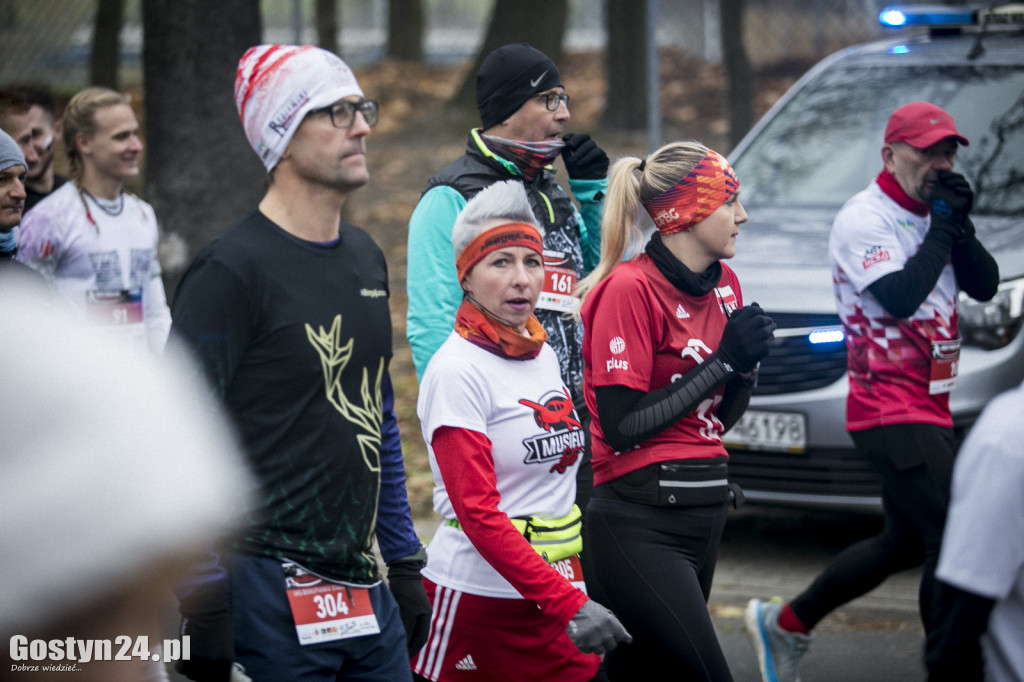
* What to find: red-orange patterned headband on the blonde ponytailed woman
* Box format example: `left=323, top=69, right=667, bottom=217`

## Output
left=644, top=150, right=739, bottom=235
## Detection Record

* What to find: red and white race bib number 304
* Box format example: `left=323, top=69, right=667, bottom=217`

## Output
left=285, top=564, right=380, bottom=646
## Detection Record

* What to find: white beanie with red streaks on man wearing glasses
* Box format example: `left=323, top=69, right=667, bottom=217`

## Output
left=234, top=45, right=364, bottom=171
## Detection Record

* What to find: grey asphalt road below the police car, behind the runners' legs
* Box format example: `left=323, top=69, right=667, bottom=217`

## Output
left=417, top=505, right=926, bottom=682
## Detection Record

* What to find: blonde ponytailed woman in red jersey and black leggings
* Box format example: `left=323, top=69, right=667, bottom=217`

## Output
left=580, top=142, right=775, bottom=682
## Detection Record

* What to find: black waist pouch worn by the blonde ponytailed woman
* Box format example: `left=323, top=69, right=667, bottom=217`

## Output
left=599, top=457, right=730, bottom=507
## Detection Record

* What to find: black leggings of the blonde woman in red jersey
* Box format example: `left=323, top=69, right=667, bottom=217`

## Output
left=584, top=485, right=732, bottom=682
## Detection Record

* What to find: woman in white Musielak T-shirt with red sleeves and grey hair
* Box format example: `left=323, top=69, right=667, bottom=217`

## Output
left=412, top=181, right=629, bottom=682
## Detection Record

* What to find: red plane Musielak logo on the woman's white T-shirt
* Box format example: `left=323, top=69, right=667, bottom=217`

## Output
left=519, top=388, right=585, bottom=474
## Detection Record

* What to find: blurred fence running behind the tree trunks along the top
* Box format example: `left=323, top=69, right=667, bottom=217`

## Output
left=0, top=0, right=897, bottom=91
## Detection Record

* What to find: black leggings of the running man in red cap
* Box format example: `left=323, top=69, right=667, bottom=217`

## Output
left=791, top=424, right=954, bottom=632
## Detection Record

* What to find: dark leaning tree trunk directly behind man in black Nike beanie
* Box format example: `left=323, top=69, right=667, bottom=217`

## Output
left=452, top=0, right=569, bottom=117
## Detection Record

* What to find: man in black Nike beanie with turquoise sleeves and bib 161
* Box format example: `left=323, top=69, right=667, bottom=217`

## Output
left=407, top=43, right=608, bottom=508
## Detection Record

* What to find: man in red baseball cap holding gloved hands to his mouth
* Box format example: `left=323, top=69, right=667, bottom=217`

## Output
left=745, top=101, right=999, bottom=682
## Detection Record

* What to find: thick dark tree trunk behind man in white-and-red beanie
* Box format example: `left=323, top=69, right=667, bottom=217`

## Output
left=142, top=0, right=265, bottom=295
